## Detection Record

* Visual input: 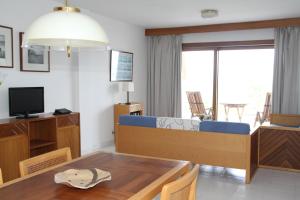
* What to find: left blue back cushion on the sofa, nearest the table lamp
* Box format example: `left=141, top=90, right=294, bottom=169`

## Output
left=119, top=115, right=156, bottom=128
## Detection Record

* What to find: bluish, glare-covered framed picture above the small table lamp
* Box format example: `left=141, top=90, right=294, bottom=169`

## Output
left=110, top=50, right=133, bottom=82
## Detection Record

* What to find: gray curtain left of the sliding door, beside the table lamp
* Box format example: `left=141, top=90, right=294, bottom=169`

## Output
left=147, top=35, right=182, bottom=117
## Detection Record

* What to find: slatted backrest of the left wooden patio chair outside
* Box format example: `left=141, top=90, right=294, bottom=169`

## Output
left=186, top=92, right=206, bottom=116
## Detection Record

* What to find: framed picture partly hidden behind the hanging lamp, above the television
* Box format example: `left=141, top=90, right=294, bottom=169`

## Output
left=19, top=32, right=50, bottom=72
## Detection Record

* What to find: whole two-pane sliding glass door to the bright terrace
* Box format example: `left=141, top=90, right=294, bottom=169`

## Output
left=182, top=40, right=274, bottom=124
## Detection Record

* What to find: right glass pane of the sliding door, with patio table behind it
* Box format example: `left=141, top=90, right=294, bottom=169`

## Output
left=218, top=49, right=274, bottom=125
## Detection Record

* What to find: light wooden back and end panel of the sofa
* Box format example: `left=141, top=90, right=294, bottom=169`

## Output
left=116, top=125, right=258, bottom=183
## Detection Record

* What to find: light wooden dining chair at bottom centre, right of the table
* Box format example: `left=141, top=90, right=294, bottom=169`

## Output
left=160, top=165, right=199, bottom=200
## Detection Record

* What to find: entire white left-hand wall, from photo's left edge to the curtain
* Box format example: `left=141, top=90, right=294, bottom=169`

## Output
left=0, top=0, right=146, bottom=154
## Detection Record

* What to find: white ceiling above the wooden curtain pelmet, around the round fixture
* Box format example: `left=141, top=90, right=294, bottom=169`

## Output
left=63, top=0, right=300, bottom=28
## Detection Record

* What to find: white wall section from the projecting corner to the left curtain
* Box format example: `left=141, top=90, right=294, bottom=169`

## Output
left=79, top=9, right=146, bottom=153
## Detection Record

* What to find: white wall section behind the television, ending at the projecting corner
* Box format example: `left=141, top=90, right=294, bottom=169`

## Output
left=0, top=0, right=78, bottom=118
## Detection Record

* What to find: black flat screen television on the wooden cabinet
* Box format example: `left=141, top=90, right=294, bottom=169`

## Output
left=9, top=87, right=44, bottom=118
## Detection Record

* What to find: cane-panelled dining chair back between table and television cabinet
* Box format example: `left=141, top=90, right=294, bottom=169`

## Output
left=19, top=147, right=72, bottom=177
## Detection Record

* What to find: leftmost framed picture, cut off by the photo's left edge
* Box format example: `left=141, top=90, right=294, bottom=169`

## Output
left=0, top=26, right=14, bottom=68
